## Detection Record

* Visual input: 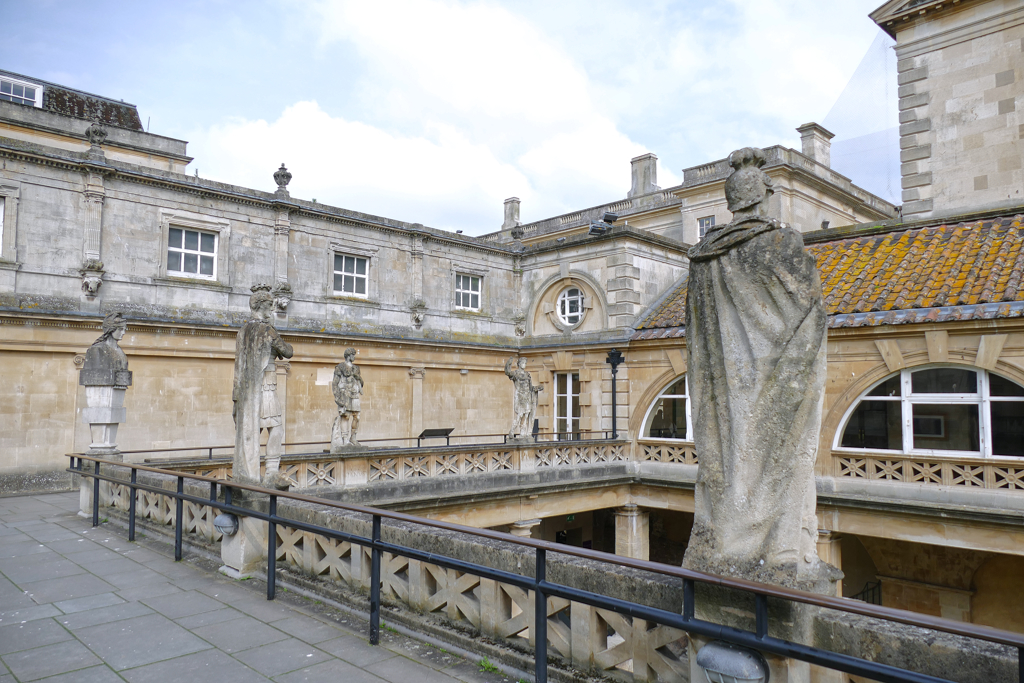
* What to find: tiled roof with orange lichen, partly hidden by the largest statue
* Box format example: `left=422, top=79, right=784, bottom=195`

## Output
left=634, top=215, right=1024, bottom=339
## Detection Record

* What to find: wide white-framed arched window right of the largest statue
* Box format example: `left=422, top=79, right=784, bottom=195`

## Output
left=836, top=367, right=1024, bottom=458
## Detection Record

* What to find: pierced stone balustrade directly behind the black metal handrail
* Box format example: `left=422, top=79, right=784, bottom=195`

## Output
left=100, top=471, right=689, bottom=683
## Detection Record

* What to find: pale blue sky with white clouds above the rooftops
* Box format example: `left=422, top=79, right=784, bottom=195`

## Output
left=0, top=0, right=899, bottom=234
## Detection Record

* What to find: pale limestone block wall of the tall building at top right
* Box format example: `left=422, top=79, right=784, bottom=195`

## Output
left=895, top=0, right=1024, bottom=218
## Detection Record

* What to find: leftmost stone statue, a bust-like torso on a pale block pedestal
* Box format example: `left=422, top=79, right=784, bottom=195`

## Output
left=78, top=313, right=131, bottom=459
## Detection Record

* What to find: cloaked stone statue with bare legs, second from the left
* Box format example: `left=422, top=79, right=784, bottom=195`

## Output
left=231, top=285, right=292, bottom=488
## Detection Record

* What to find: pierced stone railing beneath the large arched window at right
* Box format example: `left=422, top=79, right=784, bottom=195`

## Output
left=833, top=451, right=1024, bottom=490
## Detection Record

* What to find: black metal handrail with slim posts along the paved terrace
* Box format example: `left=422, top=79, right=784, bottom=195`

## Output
left=68, top=454, right=1024, bottom=683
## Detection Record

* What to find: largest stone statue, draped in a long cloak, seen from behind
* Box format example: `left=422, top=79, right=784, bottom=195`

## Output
left=683, top=147, right=842, bottom=593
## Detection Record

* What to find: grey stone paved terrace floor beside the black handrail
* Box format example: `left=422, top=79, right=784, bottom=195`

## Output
left=0, top=494, right=515, bottom=683
